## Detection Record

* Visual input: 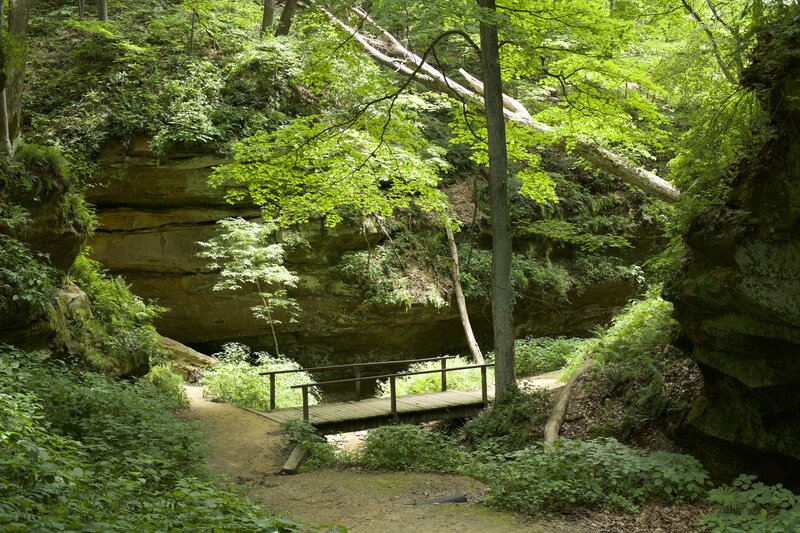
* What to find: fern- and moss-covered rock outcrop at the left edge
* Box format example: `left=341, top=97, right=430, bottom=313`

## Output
left=0, top=145, right=92, bottom=349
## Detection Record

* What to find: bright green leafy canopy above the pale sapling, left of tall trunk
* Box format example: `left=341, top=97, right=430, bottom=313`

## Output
left=213, top=103, right=454, bottom=226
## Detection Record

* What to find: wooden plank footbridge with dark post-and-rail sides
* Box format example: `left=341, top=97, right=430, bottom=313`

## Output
left=253, top=356, right=494, bottom=434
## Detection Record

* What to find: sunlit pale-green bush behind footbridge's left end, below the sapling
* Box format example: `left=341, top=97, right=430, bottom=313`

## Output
left=200, top=343, right=319, bottom=411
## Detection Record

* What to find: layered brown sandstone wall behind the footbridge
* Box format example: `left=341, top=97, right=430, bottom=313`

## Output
left=89, top=139, right=635, bottom=365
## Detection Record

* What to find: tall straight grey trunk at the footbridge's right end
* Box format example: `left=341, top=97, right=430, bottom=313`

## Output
left=478, top=0, right=516, bottom=403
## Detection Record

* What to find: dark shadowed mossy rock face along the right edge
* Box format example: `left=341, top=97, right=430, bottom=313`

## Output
left=665, top=15, right=800, bottom=472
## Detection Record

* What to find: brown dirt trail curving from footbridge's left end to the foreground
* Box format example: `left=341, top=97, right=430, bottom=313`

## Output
left=187, top=387, right=587, bottom=533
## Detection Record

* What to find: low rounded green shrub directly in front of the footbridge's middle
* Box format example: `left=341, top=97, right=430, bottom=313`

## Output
left=352, top=424, right=467, bottom=472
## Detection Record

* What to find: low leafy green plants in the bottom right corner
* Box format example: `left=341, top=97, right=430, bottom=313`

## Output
left=699, top=475, right=800, bottom=533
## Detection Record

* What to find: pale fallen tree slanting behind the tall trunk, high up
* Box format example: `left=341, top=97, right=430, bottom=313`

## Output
left=317, top=6, right=680, bottom=203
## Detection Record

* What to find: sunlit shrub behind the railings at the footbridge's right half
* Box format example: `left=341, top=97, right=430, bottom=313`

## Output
left=377, top=357, right=494, bottom=398
